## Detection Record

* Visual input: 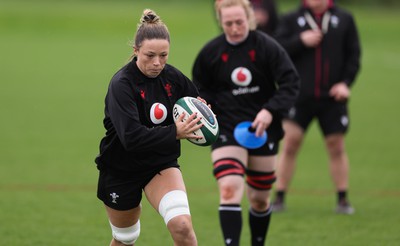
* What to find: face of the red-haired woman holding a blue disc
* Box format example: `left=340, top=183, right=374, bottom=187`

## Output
left=220, top=6, right=249, bottom=44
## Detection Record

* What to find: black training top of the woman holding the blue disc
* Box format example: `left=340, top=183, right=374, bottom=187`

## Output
left=192, top=31, right=300, bottom=135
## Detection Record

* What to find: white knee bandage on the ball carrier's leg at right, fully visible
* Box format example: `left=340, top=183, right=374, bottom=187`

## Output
left=158, top=190, right=190, bottom=224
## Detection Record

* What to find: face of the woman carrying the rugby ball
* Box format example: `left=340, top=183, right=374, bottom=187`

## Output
left=135, top=39, right=169, bottom=78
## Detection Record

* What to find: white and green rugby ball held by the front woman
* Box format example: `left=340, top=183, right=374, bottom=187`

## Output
left=173, top=97, right=219, bottom=146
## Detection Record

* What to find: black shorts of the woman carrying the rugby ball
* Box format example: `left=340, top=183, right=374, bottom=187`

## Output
left=97, top=161, right=179, bottom=211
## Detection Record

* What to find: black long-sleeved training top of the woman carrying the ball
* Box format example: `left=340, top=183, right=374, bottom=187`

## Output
left=95, top=60, right=198, bottom=178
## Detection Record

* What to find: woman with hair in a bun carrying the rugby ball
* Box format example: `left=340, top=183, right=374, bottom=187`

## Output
left=96, top=10, right=204, bottom=246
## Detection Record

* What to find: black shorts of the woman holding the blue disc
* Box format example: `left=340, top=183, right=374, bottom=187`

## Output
left=211, top=121, right=283, bottom=156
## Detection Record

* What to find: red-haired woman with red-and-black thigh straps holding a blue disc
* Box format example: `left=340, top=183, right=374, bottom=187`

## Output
left=192, top=0, right=300, bottom=246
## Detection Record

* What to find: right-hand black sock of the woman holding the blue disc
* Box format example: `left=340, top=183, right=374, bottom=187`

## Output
left=249, top=207, right=271, bottom=246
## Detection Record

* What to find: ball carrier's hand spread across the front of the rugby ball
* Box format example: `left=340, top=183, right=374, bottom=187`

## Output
left=175, top=113, right=203, bottom=139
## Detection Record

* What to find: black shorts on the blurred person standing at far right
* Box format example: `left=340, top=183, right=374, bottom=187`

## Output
left=288, top=99, right=350, bottom=136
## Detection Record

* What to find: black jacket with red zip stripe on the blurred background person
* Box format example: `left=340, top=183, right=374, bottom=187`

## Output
left=275, top=6, right=361, bottom=101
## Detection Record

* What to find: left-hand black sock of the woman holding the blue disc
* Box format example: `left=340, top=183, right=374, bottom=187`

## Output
left=219, top=204, right=242, bottom=246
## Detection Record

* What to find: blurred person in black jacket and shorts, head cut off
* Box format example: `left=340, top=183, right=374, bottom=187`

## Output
left=273, top=0, right=361, bottom=214
